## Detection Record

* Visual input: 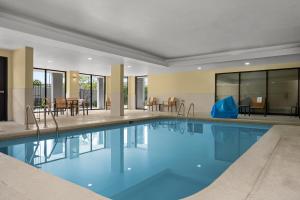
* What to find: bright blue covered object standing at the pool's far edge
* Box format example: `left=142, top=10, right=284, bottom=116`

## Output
left=210, top=96, right=238, bottom=119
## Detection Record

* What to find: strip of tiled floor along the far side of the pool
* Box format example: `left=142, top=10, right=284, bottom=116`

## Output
left=0, top=110, right=300, bottom=140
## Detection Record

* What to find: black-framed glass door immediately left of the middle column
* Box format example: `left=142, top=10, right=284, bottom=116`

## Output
left=79, top=74, right=105, bottom=110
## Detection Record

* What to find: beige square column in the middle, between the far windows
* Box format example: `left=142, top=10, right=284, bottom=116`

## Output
left=110, top=64, right=124, bottom=116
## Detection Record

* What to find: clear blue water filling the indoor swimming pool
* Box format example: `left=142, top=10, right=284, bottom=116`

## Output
left=0, top=119, right=270, bottom=200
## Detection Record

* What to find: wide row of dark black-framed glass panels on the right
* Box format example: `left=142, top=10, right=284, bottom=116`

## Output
left=215, top=68, right=300, bottom=115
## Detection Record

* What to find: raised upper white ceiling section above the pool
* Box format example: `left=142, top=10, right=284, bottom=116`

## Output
left=0, top=0, right=300, bottom=58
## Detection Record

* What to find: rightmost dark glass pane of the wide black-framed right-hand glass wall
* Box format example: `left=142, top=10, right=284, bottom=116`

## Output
left=268, top=69, right=298, bottom=114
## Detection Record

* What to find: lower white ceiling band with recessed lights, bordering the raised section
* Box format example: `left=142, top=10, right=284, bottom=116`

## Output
left=0, top=27, right=300, bottom=76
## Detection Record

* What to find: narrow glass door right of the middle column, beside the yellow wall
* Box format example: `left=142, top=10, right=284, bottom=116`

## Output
left=135, top=76, right=148, bottom=109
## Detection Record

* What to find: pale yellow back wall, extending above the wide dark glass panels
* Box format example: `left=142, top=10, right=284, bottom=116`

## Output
left=148, top=62, right=300, bottom=113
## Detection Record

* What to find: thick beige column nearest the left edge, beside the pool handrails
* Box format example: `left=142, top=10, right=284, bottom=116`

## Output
left=12, top=47, right=33, bottom=124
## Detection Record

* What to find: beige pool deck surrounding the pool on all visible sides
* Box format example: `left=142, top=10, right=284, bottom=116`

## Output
left=0, top=111, right=300, bottom=200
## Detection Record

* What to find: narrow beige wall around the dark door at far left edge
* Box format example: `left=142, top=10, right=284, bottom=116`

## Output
left=0, top=49, right=13, bottom=120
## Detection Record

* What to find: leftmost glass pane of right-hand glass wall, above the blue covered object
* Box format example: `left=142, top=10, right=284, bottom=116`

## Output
left=216, top=73, right=239, bottom=104
